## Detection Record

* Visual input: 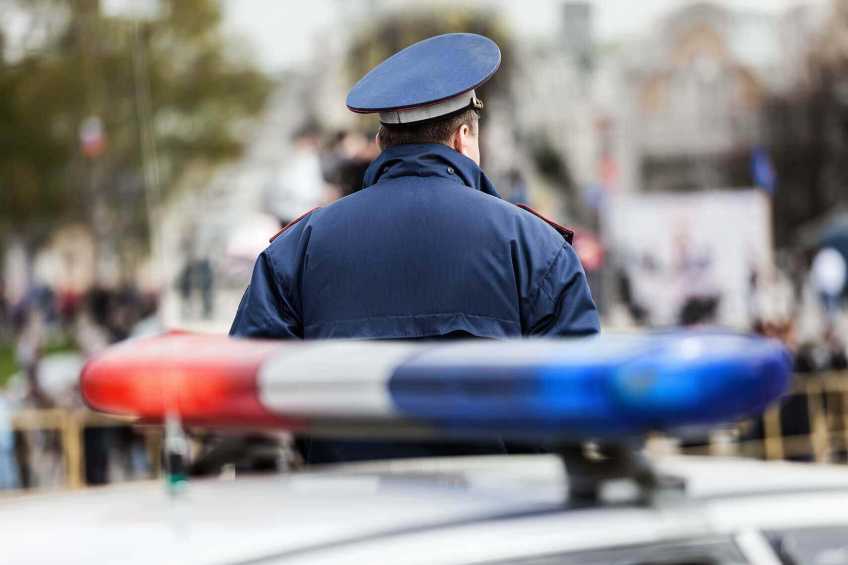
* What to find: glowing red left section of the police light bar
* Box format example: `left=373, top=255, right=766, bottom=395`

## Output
left=80, top=333, right=304, bottom=430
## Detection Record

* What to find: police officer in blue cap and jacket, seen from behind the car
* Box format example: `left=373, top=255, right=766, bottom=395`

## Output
left=230, top=33, right=599, bottom=460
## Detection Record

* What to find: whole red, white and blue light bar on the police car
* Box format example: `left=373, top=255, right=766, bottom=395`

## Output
left=81, top=332, right=791, bottom=441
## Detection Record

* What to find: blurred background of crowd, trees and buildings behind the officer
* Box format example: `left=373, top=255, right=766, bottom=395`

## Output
left=0, top=0, right=848, bottom=489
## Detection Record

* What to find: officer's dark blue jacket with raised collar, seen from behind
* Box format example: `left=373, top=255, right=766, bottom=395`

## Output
left=230, top=144, right=599, bottom=339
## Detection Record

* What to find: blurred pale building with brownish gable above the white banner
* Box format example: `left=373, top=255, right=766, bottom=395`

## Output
left=620, top=3, right=816, bottom=191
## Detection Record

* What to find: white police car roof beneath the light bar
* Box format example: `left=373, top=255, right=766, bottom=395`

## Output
left=0, top=456, right=848, bottom=565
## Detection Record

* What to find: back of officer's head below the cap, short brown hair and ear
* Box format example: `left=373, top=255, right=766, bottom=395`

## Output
left=377, top=108, right=480, bottom=165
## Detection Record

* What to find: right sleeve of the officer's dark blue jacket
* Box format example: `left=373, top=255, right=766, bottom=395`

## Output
left=524, top=242, right=601, bottom=336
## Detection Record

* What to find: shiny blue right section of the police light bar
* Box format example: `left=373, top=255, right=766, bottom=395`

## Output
left=389, top=332, right=792, bottom=440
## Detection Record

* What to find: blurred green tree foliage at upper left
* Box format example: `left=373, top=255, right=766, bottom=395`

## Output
left=0, top=0, right=270, bottom=249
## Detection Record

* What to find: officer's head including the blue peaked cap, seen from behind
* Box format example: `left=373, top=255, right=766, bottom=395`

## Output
left=347, top=33, right=501, bottom=165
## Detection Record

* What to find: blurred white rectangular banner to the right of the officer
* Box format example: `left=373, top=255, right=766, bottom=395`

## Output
left=607, top=189, right=772, bottom=328
